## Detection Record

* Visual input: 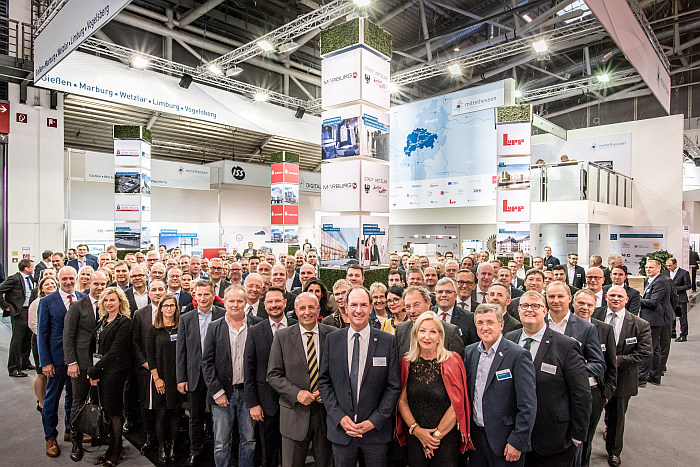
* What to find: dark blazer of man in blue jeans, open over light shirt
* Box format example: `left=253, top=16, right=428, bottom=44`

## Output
left=202, top=315, right=262, bottom=404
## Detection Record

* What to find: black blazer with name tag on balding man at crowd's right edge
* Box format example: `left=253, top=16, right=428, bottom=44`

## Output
left=593, top=307, right=652, bottom=397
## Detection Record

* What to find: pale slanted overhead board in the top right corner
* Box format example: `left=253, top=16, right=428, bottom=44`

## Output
left=586, top=0, right=671, bottom=113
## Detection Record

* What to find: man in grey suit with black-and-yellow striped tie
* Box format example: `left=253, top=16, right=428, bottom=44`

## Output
left=267, top=293, right=336, bottom=467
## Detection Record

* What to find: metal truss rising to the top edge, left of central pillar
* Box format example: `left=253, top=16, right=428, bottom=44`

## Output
left=199, top=0, right=356, bottom=73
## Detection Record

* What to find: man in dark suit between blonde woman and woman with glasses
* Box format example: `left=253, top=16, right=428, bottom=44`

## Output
left=131, top=280, right=166, bottom=453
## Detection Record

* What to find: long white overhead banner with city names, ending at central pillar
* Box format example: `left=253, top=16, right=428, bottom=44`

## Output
left=35, top=52, right=320, bottom=145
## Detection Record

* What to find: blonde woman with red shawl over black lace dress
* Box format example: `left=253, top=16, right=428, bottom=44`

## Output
left=396, top=311, right=471, bottom=467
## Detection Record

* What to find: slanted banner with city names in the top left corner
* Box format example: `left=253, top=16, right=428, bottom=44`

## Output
left=34, top=0, right=131, bottom=82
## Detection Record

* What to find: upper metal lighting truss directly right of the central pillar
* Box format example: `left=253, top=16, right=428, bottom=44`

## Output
left=391, top=18, right=605, bottom=86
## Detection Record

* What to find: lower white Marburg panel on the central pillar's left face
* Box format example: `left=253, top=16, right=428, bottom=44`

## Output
left=321, top=160, right=362, bottom=212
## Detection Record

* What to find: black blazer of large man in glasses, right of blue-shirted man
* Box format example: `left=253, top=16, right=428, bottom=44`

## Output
left=506, top=328, right=591, bottom=456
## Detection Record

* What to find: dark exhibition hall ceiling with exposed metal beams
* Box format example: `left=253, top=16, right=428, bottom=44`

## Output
left=34, top=0, right=700, bottom=166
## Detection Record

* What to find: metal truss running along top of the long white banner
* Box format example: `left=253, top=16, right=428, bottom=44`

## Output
left=79, top=37, right=320, bottom=113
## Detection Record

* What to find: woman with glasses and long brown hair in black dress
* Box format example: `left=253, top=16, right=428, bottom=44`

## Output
left=146, top=295, right=182, bottom=465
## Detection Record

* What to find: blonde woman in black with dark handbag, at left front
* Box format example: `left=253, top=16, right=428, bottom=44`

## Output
left=88, top=287, right=131, bottom=467
